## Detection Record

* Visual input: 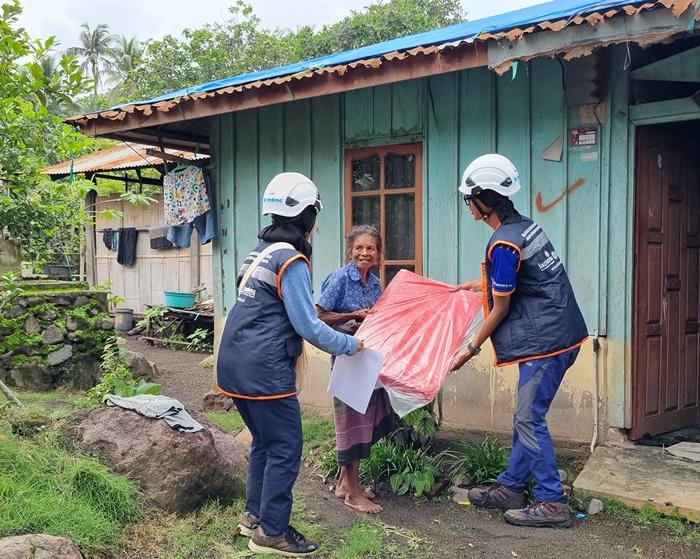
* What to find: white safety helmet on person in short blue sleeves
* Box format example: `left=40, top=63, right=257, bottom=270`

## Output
left=459, top=153, right=520, bottom=196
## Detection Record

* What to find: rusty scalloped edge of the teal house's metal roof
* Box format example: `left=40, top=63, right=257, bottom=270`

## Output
left=65, top=0, right=700, bottom=130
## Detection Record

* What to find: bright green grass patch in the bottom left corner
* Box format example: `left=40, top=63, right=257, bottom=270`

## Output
left=0, top=421, right=141, bottom=551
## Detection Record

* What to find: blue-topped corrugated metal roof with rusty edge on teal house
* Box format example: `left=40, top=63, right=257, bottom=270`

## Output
left=67, top=0, right=700, bottom=125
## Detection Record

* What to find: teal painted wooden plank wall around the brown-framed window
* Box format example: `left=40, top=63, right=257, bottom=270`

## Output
left=212, top=59, right=628, bottom=348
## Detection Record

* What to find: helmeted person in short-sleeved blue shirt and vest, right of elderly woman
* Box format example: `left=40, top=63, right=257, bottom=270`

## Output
left=450, top=154, right=588, bottom=527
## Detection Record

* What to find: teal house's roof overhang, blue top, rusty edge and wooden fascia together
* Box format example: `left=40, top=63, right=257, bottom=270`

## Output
left=67, top=0, right=700, bottom=149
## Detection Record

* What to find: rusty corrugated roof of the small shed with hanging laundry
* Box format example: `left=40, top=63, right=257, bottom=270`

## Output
left=41, top=142, right=209, bottom=176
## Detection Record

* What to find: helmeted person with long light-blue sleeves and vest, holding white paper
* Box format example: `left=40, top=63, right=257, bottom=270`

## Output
left=217, top=172, right=362, bottom=557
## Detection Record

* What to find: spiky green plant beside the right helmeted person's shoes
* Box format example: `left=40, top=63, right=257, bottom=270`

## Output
left=441, top=435, right=508, bottom=485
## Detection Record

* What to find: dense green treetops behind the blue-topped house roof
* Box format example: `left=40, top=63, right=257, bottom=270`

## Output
left=131, top=0, right=465, bottom=102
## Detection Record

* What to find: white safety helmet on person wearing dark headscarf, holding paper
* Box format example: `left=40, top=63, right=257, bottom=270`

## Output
left=262, top=172, right=323, bottom=217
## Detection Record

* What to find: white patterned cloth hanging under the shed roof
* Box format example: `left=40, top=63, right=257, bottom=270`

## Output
left=163, top=165, right=211, bottom=225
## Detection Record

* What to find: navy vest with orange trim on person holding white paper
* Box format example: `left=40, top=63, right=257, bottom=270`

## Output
left=216, top=242, right=308, bottom=399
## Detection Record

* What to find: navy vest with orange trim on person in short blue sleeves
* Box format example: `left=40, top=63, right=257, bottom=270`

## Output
left=484, top=216, right=588, bottom=366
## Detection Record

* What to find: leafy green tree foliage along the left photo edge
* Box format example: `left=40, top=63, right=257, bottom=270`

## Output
left=0, top=0, right=89, bottom=259
